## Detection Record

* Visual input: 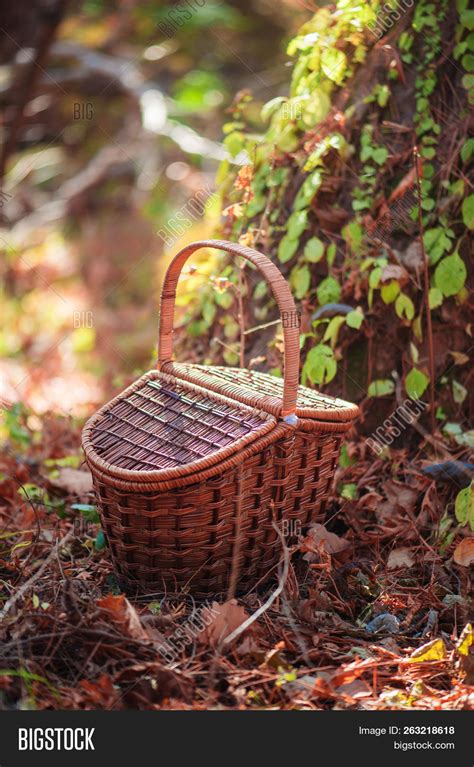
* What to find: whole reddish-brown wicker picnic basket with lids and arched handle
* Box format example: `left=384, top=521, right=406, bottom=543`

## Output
left=83, top=240, right=358, bottom=598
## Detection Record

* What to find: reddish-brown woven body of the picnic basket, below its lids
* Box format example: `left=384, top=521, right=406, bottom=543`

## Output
left=84, top=365, right=350, bottom=598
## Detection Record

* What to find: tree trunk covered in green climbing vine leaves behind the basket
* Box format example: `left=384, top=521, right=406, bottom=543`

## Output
left=180, top=0, right=474, bottom=443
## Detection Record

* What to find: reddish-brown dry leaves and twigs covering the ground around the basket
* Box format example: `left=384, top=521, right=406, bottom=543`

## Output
left=0, top=421, right=474, bottom=709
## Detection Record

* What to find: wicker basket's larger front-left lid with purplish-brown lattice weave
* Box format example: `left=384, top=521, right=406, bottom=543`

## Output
left=83, top=370, right=277, bottom=481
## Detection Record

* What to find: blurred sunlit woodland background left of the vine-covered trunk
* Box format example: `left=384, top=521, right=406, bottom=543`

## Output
left=0, top=0, right=311, bottom=415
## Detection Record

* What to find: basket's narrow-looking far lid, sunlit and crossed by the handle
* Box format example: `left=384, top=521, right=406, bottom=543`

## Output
left=162, top=362, right=359, bottom=423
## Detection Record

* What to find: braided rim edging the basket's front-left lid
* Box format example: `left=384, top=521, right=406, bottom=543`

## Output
left=82, top=370, right=278, bottom=484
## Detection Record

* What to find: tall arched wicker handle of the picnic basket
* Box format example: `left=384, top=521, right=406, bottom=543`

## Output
left=157, top=240, right=300, bottom=423
